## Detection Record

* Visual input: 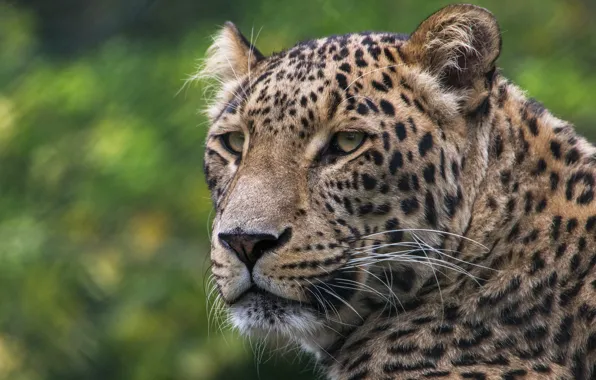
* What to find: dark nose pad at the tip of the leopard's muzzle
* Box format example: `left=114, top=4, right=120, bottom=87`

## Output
left=217, top=228, right=292, bottom=270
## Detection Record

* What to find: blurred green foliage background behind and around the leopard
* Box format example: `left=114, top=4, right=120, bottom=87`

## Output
left=0, top=0, right=596, bottom=380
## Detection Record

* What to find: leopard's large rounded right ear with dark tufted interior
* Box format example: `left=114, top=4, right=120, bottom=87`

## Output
left=403, top=4, right=501, bottom=89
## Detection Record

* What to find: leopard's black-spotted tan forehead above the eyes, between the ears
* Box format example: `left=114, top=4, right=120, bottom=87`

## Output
left=214, top=32, right=407, bottom=138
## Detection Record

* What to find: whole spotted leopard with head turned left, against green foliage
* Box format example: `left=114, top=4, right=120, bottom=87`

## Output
left=195, top=4, right=596, bottom=380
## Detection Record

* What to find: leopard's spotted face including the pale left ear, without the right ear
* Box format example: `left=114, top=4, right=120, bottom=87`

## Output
left=205, top=6, right=502, bottom=350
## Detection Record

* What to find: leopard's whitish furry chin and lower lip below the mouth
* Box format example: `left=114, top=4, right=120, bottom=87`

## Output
left=229, top=287, right=324, bottom=341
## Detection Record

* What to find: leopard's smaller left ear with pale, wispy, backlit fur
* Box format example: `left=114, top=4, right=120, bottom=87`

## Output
left=199, top=21, right=265, bottom=83
